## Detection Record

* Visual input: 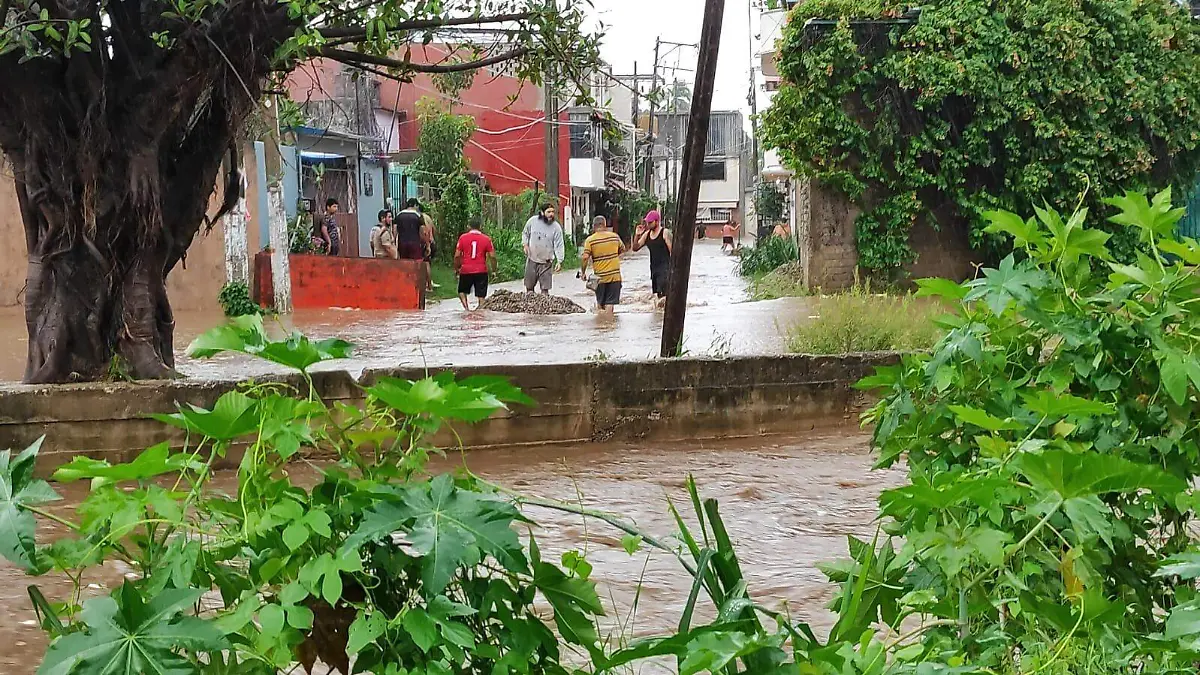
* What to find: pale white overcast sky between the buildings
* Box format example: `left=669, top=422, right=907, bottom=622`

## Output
left=593, top=0, right=761, bottom=120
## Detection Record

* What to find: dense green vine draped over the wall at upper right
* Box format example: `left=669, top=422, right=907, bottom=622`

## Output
left=761, top=0, right=1200, bottom=270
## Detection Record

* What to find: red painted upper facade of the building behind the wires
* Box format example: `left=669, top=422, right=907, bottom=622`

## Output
left=288, top=44, right=571, bottom=204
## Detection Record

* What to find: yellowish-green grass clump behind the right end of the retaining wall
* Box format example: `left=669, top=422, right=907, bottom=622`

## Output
left=787, top=287, right=944, bottom=354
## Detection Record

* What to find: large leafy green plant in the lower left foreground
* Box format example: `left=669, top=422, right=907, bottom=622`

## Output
left=0, top=316, right=628, bottom=675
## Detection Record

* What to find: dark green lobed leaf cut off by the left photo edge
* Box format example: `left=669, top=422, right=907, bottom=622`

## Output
left=0, top=438, right=59, bottom=571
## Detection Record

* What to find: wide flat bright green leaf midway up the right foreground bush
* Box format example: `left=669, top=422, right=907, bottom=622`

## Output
left=1014, top=449, right=1187, bottom=501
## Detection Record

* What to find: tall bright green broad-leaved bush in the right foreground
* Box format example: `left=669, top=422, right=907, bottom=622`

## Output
left=854, top=191, right=1200, bottom=674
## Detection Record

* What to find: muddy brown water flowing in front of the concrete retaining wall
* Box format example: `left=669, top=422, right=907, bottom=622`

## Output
left=0, top=429, right=902, bottom=675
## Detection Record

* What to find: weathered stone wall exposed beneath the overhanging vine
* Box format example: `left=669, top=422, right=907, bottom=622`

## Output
left=796, top=180, right=977, bottom=292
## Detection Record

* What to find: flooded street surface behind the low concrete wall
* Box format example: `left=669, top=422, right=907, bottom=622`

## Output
left=0, top=240, right=810, bottom=382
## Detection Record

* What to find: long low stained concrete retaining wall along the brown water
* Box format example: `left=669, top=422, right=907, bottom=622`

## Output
left=0, top=354, right=896, bottom=472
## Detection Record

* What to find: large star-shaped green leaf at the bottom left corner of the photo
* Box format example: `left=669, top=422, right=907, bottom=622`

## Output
left=37, top=584, right=228, bottom=675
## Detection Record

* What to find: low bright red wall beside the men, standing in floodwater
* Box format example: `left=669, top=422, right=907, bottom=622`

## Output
left=254, top=251, right=426, bottom=310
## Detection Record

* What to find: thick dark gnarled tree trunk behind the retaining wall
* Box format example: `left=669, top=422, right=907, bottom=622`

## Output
left=0, top=0, right=288, bottom=383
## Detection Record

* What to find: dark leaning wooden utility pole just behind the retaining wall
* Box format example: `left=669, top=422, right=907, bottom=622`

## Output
left=661, top=0, right=725, bottom=357
